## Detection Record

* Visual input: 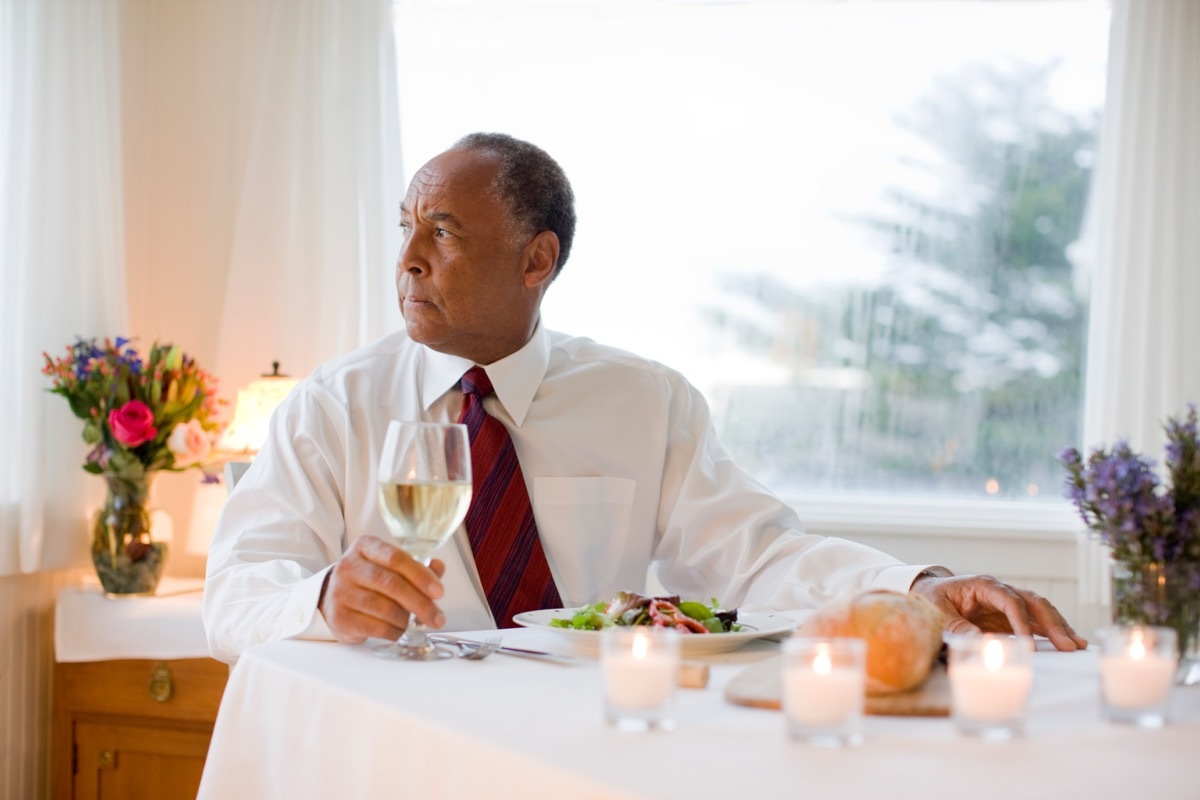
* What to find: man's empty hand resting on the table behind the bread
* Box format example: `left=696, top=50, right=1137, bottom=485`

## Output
left=910, top=575, right=1087, bottom=651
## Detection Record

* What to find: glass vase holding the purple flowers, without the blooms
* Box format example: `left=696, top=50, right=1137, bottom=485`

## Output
left=1112, top=561, right=1200, bottom=685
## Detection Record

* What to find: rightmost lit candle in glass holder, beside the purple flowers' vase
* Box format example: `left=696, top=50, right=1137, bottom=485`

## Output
left=1097, top=625, right=1176, bottom=728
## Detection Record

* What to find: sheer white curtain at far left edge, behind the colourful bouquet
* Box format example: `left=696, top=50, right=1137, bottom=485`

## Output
left=0, top=0, right=126, bottom=575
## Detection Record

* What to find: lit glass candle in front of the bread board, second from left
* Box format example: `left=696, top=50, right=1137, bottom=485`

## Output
left=780, top=636, right=866, bottom=747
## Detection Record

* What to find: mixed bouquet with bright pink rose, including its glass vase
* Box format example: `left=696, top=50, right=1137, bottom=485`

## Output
left=42, top=337, right=222, bottom=595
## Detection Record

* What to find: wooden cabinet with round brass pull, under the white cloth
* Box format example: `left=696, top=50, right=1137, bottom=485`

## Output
left=54, top=658, right=229, bottom=800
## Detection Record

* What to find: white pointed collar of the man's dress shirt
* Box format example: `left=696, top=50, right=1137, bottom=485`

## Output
left=421, top=319, right=550, bottom=427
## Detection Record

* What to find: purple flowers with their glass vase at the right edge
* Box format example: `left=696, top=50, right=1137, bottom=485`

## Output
left=1058, top=405, right=1200, bottom=684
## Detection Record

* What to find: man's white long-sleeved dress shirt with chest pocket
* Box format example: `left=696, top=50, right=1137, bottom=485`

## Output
left=204, top=324, right=928, bottom=662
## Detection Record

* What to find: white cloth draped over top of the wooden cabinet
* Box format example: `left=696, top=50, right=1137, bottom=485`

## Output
left=54, top=578, right=209, bottom=661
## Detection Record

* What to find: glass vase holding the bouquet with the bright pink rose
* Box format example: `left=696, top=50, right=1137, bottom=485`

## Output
left=91, top=474, right=167, bottom=597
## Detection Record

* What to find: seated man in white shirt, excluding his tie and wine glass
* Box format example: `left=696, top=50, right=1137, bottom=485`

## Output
left=204, top=134, right=1086, bottom=661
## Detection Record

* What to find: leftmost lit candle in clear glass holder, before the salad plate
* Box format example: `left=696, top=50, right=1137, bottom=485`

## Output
left=600, top=627, right=680, bottom=730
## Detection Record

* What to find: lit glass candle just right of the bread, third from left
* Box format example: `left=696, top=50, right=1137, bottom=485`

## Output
left=948, top=633, right=1033, bottom=740
